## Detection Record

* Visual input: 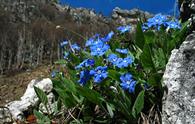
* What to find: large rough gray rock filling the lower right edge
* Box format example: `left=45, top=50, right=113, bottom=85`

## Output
left=162, top=33, right=195, bottom=124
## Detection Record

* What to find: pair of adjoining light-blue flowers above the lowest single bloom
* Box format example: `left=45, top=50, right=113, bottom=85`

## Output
left=107, top=54, right=133, bottom=68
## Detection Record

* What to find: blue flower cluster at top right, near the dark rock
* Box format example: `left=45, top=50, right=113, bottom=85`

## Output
left=142, top=14, right=181, bottom=31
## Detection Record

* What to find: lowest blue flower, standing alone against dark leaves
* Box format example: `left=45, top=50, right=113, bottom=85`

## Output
left=120, top=73, right=136, bottom=93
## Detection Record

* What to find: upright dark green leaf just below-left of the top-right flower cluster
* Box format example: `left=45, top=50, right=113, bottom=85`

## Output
left=135, top=23, right=145, bottom=49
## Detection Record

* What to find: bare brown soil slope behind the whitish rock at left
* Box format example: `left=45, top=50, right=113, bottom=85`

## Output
left=0, top=66, right=50, bottom=106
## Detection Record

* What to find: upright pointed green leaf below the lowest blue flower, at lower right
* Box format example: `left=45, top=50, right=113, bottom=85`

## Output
left=132, top=90, right=144, bottom=118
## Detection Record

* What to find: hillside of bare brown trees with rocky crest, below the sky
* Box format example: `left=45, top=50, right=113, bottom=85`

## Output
left=0, top=0, right=151, bottom=74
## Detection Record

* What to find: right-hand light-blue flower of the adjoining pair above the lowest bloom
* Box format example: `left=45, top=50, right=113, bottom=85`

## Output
left=116, top=56, right=133, bottom=68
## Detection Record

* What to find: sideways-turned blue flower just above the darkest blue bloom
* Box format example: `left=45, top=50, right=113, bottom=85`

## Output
left=75, top=59, right=95, bottom=69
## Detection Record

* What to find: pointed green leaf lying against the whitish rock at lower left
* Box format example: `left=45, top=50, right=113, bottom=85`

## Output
left=34, top=86, right=48, bottom=105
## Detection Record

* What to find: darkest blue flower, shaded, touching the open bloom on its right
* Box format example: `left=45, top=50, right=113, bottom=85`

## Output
left=78, top=70, right=91, bottom=86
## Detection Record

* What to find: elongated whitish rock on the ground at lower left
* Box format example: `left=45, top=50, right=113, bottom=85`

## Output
left=5, top=78, right=53, bottom=120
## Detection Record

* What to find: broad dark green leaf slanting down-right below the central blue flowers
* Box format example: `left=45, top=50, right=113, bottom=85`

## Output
left=77, top=86, right=104, bottom=105
